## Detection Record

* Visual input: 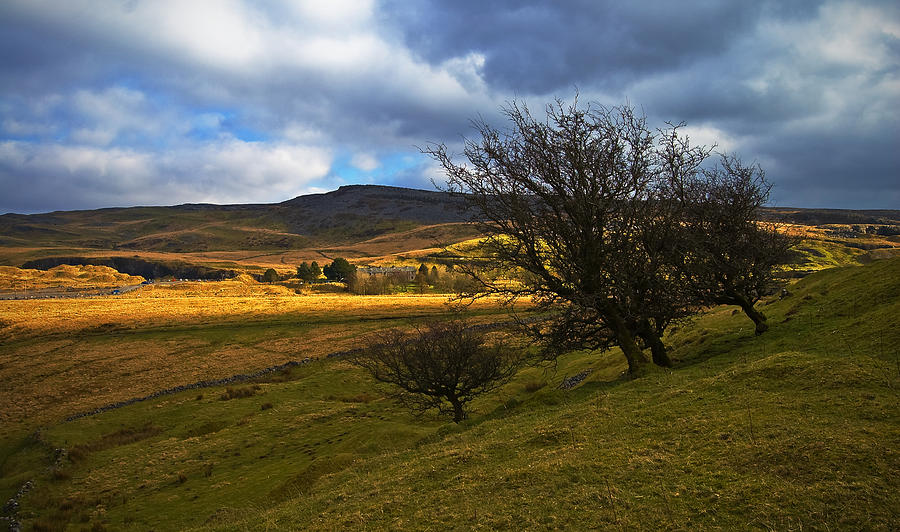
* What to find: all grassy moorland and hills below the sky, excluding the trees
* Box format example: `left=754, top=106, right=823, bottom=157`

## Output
left=0, top=187, right=900, bottom=530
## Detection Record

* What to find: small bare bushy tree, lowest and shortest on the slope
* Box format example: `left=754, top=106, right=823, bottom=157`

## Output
left=350, top=319, right=519, bottom=423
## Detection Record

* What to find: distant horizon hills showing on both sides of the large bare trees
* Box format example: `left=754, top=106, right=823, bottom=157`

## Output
left=0, top=185, right=900, bottom=268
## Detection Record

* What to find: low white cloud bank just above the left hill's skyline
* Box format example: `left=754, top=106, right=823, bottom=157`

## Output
left=0, top=138, right=332, bottom=210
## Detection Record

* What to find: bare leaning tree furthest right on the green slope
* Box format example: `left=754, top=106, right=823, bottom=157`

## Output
left=676, top=155, right=794, bottom=334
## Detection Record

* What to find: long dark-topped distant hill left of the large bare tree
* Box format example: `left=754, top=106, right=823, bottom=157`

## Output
left=0, top=185, right=472, bottom=253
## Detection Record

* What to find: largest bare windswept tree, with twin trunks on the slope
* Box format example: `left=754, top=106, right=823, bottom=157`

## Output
left=425, top=100, right=708, bottom=373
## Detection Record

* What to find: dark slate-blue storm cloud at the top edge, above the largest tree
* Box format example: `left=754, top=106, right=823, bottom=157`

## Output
left=391, top=0, right=809, bottom=94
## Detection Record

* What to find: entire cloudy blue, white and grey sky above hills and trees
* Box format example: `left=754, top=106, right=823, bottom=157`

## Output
left=0, top=0, right=900, bottom=213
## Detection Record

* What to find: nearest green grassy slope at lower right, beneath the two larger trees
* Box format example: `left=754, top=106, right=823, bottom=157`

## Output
left=211, top=259, right=900, bottom=530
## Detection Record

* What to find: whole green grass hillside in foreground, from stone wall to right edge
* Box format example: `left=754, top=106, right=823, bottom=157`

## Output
left=8, top=259, right=900, bottom=530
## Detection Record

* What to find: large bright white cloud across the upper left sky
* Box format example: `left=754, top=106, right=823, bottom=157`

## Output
left=0, top=0, right=497, bottom=163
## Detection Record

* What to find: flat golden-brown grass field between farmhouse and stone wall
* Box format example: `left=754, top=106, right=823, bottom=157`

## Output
left=0, top=276, right=506, bottom=426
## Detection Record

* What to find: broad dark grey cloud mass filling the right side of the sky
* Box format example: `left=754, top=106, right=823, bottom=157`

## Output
left=382, top=1, right=900, bottom=208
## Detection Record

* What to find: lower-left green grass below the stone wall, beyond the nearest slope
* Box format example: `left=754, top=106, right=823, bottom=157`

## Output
left=9, top=364, right=450, bottom=529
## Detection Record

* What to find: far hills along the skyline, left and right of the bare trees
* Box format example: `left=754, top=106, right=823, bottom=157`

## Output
left=0, top=185, right=900, bottom=278
